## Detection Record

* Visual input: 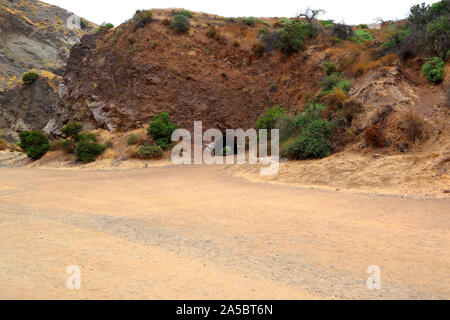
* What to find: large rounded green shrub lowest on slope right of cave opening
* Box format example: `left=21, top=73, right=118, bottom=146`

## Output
left=287, top=119, right=332, bottom=160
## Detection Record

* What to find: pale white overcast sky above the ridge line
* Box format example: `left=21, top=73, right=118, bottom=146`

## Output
left=44, top=0, right=437, bottom=25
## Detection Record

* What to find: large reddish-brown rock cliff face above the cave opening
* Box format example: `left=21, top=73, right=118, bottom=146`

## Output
left=48, top=10, right=321, bottom=134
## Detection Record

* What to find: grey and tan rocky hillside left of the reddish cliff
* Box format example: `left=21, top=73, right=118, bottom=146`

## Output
left=0, top=0, right=95, bottom=140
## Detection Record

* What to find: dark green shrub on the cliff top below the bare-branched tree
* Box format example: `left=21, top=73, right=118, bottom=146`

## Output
left=278, top=21, right=317, bottom=53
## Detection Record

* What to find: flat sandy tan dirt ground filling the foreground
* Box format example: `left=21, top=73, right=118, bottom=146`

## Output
left=0, top=166, right=450, bottom=299
